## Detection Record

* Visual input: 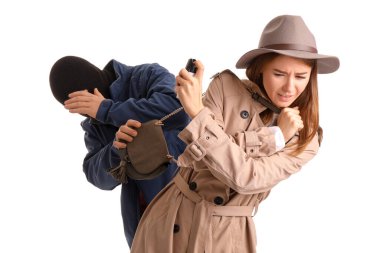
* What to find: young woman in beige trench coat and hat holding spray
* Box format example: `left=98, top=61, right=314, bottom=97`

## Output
left=114, top=15, right=339, bottom=253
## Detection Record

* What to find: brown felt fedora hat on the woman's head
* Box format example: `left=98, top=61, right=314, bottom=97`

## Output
left=236, top=15, right=339, bottom=74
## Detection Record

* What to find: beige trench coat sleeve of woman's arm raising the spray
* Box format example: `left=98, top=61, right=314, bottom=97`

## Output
left=178, top=75, right=319, bottom=194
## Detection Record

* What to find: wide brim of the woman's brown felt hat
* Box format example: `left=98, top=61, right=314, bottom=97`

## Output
left=236, top=48, right=340, bottom=74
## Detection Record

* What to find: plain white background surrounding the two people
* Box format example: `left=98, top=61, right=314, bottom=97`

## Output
left=0, top=0, right=380, bottom=253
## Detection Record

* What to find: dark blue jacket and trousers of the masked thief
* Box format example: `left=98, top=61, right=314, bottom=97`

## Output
left=81, top=60, right=189, bottom=246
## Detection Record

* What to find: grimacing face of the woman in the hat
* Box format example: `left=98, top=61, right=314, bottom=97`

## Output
left=262, top=55, right=311, bottom=108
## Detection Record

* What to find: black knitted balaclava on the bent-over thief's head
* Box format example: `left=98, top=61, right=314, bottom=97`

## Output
left=49, top=56, right=116, bottom=104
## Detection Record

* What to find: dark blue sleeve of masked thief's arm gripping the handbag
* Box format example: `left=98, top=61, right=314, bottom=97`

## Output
left=82, top=121, right=120, bottom=190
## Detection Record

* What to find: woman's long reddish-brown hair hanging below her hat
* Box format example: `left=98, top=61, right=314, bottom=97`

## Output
left=246, top=53, right=323, bottom=155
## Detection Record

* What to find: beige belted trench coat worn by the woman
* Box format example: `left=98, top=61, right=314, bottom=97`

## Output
left=131, top=70, right=319, bottom=253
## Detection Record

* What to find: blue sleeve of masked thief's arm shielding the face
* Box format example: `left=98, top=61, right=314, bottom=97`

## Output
left=96, top=63, right=188, bottom=128
